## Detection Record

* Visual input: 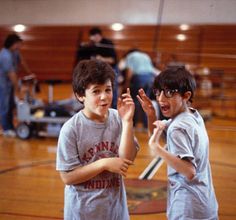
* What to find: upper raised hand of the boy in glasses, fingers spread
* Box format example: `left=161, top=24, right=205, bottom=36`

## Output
left=137, top=89, right=156, bottom=117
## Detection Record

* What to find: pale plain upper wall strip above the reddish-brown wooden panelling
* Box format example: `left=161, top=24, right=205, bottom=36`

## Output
left=0, top=0, right=236, bottom=25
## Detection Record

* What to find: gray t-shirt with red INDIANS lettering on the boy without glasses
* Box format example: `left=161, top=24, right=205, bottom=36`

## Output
left=56, top=109, right=129, bottom=220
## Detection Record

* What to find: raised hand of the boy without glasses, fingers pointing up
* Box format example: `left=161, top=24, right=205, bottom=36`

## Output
left=117, top=88, right=135, bottom=121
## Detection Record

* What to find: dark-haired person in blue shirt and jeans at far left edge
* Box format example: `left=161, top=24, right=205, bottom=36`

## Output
left=0, top=34, right=32, bottom=137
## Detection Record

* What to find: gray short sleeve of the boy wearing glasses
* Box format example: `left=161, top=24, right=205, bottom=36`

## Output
left=168, top=128, right=196, bottom=167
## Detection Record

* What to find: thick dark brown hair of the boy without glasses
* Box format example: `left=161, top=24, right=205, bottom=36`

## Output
left=72, top=59, right=115, bottom=96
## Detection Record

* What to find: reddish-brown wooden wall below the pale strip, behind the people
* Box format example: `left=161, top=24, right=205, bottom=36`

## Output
left=0, top=24, right=236, bottom=81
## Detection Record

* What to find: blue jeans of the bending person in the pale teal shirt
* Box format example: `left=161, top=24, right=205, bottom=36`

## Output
left=130, top=73, right=154, bottom=128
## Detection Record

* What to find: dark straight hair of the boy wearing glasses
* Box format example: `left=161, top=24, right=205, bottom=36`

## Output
left=153, top=67, right=196, bottom=102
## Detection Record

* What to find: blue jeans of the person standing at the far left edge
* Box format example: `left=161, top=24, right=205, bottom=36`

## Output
left=0, top=85, right=15, bottom=131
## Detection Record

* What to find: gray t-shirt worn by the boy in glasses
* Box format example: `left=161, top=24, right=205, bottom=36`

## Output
left=167, top=109, right=218, bottom=220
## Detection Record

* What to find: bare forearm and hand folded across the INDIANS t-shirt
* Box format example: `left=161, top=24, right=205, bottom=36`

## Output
left=60, top=157, right=133, bottom=185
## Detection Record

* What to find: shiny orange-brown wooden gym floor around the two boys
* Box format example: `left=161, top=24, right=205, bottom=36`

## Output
left=0, top=85, right=236, bottom=220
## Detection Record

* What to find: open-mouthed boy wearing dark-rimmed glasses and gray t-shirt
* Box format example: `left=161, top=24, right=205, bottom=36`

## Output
left=138, top=68, right=218, bottom=220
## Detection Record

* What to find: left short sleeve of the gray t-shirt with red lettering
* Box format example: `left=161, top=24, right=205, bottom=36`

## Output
left=56, top=123, right=81, bottom=171
